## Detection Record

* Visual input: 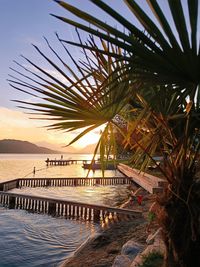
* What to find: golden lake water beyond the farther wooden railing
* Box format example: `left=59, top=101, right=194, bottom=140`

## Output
left=0, top=154, right=124, bottom=181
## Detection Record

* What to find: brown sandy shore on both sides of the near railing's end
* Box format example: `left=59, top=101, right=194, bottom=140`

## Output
left=59, top=186, right=153, bottom=267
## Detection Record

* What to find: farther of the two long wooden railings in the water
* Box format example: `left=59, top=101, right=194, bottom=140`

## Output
left=0, top=177, right=131, bottom=191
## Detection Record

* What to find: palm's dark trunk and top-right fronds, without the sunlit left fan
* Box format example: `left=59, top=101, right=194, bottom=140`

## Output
left=50, top=0, right=200, bottom=266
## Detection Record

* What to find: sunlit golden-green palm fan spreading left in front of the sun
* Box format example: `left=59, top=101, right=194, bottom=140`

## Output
left=8, top=31, right=132, bottom=167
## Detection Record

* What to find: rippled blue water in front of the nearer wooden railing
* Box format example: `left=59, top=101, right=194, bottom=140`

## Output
left=0, top=208, right=98, bottom=267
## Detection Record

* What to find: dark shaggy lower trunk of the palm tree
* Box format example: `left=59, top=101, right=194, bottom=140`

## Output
left=160, top=181, right=200, bottom=267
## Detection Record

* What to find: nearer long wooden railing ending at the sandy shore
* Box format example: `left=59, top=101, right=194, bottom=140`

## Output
left=0, top=192, right=142, bottom=221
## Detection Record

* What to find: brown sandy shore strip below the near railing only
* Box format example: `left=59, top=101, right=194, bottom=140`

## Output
left=59, top=219, right=146, bottom=267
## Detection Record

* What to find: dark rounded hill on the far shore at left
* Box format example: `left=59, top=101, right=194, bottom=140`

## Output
left=0, top=139, right=63, bottom=154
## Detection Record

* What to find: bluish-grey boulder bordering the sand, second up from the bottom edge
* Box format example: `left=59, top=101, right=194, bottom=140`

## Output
left=121, top=240, right=143, bottom=260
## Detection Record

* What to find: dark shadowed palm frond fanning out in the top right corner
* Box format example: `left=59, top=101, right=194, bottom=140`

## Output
left=56, top=0, right=200, bottom=88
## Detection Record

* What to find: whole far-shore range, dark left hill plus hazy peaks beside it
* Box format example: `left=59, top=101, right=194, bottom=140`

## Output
left=0, top=139, right=96, bottom=154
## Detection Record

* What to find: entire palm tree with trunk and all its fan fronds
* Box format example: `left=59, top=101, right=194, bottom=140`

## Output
left=10, top=0, right=200, bottom=267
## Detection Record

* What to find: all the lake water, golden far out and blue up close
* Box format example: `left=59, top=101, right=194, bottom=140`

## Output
left=0, top=154, right=128, bottom=267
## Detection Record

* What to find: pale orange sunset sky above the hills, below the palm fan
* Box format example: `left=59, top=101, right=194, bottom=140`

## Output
left=0, top=107, right=103, bottom=150
